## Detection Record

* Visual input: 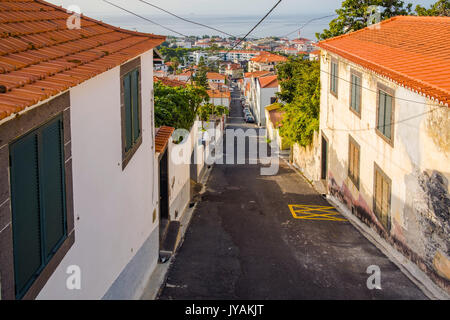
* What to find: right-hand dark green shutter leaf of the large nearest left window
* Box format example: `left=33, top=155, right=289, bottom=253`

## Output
left=40, top=119, right=66, bottom=260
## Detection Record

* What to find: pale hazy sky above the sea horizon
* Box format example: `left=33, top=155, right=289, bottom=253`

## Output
left=50, top=0, right=436, bottom=16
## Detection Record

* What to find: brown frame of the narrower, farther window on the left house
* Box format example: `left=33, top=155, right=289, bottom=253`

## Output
left=120, top=57, right=142, bottom=170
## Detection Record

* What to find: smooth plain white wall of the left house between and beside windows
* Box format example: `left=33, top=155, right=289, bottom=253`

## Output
left=38, top=51, right=158, bottom=299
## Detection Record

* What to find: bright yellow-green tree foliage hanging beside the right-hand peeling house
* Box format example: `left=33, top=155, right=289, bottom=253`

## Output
left=277, top=57, right=320, bottom=146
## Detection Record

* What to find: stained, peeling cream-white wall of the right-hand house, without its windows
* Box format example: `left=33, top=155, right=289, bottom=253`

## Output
left=320, top=51, right=450, bottom=277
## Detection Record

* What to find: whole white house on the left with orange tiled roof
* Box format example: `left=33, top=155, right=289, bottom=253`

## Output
left=0, top=1, right=165, bottom=299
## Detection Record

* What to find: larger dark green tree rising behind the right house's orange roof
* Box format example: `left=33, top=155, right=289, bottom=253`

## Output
left=316, top=0, right=414, bottom=40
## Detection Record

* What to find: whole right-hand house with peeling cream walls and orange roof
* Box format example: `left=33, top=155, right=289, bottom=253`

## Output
left=316, top=17, right=450, bottom=292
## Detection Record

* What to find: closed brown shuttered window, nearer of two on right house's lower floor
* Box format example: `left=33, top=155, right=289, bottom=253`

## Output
left=373, top=163, right=392, bottom=231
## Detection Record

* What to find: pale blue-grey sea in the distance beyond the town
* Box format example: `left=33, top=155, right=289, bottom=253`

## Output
left=95, top=13, right=333, bottom=41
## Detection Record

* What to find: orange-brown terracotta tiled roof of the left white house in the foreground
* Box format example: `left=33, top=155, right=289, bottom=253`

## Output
left=0, top=0, right=165, bottom=120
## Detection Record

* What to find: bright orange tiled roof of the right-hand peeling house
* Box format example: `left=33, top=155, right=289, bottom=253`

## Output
left=318, top=16, right=450, bottom=105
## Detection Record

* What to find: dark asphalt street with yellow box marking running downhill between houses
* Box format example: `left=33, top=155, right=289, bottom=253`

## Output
left=159, top=85, right=426, bottom=300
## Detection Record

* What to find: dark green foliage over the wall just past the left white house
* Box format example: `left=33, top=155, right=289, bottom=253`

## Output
left=154, top=82, right=209, bottom=130
